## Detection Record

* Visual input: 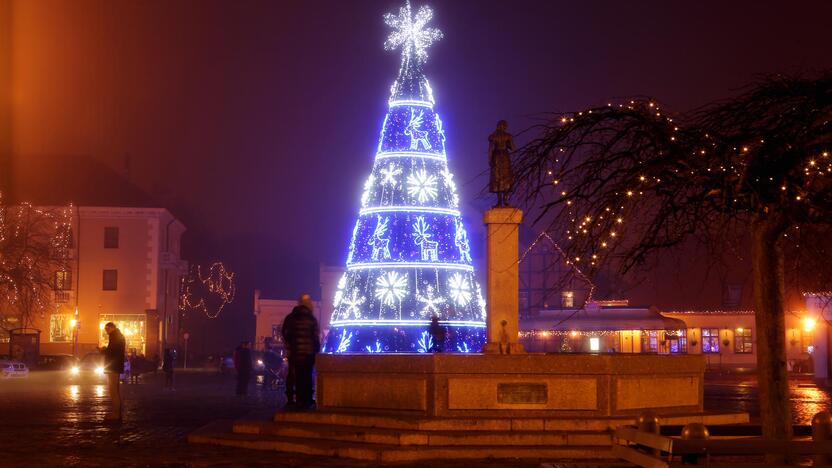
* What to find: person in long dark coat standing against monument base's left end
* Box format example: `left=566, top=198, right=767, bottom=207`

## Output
left=281, top=294, right=321, bottom=409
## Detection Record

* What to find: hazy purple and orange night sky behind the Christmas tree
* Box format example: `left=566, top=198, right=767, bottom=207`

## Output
left=0, top=0, right=832, bottom=352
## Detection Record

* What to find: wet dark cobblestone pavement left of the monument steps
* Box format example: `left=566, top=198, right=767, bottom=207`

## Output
left=0, top=372, right=537, bottom=468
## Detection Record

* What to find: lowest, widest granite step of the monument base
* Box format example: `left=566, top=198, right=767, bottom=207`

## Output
left=188, top=421, right=613, bottom=463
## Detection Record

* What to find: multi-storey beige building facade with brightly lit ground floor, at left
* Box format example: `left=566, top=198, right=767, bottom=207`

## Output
left=34, top=206, right=187, bottom=356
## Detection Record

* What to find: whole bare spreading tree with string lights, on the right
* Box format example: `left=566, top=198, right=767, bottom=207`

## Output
left=517, top=73, right=832, bottom=450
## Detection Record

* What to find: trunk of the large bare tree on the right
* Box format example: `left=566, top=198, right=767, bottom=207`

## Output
left=751, top=216, right=792, bottom=454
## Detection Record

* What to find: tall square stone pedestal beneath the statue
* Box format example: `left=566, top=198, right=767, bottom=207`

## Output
left=483, top=208, right=525, bottom=354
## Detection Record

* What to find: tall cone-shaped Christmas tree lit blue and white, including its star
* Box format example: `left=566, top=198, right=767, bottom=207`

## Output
left=324, top=1, right=485, bottom=353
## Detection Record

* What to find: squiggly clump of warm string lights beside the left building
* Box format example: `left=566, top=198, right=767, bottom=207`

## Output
left=179, top=262, right=237, bottom=318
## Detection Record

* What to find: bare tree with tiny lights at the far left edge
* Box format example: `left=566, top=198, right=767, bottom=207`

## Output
left=0, top=196, right=72, bottom=331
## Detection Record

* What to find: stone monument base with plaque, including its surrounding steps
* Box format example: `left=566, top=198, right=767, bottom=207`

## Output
left=188, top=354, right=748, bottom=462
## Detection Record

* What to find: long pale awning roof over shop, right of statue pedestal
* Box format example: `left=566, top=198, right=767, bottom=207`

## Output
left=520, top=307, right=686, bottom=332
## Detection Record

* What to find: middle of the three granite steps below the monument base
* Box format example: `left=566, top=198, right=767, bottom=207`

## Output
left=234, top=420, right=612, bottom=447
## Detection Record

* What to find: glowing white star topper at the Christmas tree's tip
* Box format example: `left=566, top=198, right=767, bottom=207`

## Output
left=384, top=0, right=442, bottom=63
